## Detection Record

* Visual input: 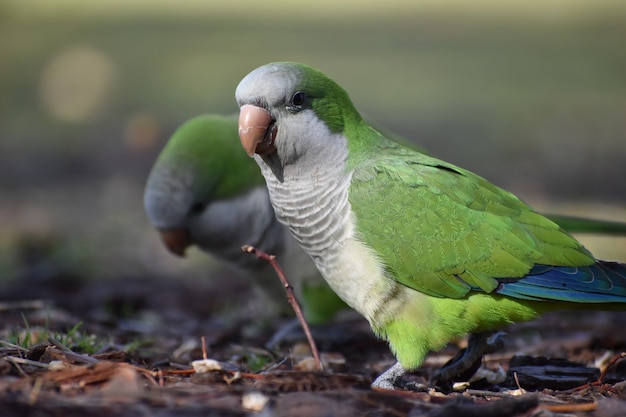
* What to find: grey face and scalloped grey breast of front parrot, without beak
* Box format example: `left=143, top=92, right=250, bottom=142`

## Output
left=237, top=64, right=350, bottom=270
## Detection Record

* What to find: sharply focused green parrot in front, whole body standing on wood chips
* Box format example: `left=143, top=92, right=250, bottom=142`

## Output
left=235, top=62, right=626, bottom=389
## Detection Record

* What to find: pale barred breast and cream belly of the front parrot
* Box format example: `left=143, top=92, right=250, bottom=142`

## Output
left=255, top=141, right=404, bottom=327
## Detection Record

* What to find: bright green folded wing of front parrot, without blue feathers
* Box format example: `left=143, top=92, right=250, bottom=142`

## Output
left=349, top=138, right=594, bottom=298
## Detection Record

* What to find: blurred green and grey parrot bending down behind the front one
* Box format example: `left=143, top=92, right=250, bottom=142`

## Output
left=144, top=115, right=347, bottom=323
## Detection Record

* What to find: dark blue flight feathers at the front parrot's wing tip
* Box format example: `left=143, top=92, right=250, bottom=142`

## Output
left=495, top=261, right=626, bottom=303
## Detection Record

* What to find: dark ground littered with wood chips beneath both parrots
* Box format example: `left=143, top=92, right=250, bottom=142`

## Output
left=0, top=258, right=626, bottom=417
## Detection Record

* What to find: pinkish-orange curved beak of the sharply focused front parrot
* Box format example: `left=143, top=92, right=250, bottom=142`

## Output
left=239, top=104, right=277, bottom=157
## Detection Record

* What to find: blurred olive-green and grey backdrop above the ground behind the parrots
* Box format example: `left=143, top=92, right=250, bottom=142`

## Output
left=0, top=0, right=626, bottom=278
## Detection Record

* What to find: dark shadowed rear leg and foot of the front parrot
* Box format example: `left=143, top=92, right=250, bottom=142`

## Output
left=429, top=332, right=506, bottom=392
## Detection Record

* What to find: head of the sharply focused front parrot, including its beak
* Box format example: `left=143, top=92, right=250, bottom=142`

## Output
left=235, top=62, right=362, bottom=166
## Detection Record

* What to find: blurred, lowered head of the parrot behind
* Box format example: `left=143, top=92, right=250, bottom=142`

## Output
left=144, top=115, right=263, bottom=256
